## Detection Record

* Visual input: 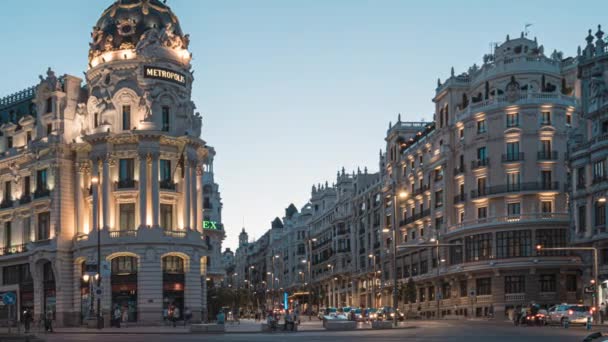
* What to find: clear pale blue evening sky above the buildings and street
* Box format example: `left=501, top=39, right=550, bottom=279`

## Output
left=0, top=0, right=608, bottom=248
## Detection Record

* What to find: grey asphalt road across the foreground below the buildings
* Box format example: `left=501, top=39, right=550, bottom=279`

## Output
left=45, top=321, right=608, bottom=342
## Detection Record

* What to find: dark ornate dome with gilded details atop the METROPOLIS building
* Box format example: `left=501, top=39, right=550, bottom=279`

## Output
left=89, top=0, right=188, bottom=58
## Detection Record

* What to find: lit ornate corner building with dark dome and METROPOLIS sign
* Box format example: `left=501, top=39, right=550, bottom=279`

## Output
left=0, top=0, right=224, bottom=325
